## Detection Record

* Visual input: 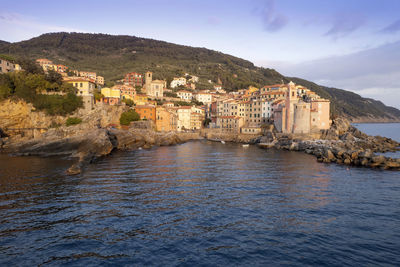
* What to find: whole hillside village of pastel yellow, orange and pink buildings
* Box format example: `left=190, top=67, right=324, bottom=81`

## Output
left=1, top=58, right=331, bottom=135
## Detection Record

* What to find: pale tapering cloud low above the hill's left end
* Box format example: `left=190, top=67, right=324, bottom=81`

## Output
left=0, top=12, right=86, bottom=42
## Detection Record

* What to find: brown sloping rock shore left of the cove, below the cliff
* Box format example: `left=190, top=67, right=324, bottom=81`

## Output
left=0, top=126, right=201, bottom=175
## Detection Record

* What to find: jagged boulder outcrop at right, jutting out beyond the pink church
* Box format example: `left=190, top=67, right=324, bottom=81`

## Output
left=258, top=118, right=400, bottom=170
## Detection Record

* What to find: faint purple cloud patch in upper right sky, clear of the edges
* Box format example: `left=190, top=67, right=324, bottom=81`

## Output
left=324, top=14, right=366, bottom=39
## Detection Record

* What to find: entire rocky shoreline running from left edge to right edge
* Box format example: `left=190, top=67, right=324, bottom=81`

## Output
left=0, top=118, right=400, bottom=175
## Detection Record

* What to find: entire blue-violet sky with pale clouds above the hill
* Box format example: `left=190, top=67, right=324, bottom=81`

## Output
left=0, top=0, right=400, bottom=108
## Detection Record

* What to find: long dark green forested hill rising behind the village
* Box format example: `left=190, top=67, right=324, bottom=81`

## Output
left=0, top=32, right=400, bottom=120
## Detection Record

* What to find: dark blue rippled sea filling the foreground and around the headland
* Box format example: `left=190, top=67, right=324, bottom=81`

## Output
left=0, top=124, right=400, bottom=266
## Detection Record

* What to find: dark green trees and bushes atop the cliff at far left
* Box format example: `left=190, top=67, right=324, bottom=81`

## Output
left=0, top=71, right=82, bottom=115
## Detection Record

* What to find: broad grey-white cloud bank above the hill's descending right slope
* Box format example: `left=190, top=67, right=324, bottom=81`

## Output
left=265, top=41, right=400, bottom=109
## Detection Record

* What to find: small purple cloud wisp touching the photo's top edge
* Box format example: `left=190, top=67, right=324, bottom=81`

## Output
left=257, top=0, right=289, bottom=32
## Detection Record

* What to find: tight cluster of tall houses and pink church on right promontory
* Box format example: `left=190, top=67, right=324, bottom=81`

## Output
left=210, top=82, right=330, bottom=134
